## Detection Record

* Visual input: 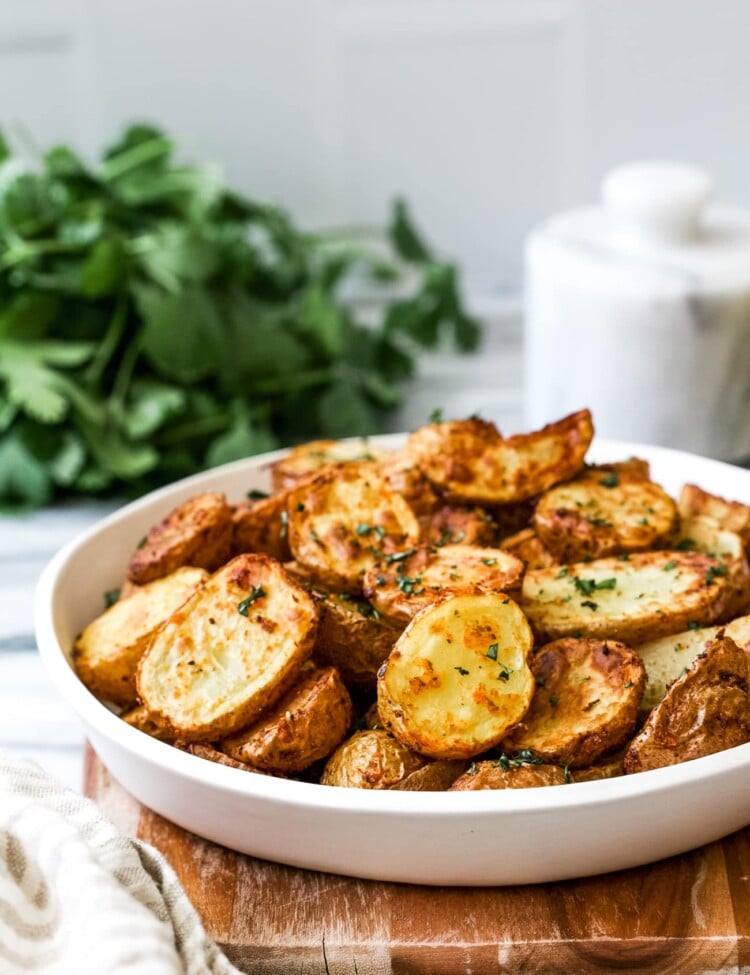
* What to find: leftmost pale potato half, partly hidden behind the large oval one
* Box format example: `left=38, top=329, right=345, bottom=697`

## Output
left=72, top=568, right=208, bottom=707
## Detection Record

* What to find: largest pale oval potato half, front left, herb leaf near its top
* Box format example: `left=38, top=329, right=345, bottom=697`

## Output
left=137, top=555, right=318, bottom=741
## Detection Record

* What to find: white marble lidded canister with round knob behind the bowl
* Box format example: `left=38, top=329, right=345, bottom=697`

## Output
left=524, top=161, right=750, bottom=460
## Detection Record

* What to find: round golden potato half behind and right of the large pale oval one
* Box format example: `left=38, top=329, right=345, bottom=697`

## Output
left=289, top=464, right=419, bottom=593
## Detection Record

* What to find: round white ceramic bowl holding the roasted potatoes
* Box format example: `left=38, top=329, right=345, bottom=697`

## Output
left=36, top=438, right=750, bottom=885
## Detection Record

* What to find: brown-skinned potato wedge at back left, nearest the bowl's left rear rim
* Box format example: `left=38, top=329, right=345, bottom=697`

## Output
left=128, top=491, right=232, bottom=585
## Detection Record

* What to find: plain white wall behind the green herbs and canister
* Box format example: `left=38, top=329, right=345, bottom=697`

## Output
left=0, top=0, right=750, bottom=295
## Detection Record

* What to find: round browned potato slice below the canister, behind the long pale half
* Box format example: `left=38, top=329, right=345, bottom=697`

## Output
left=534, top=471, right=677, bottom=562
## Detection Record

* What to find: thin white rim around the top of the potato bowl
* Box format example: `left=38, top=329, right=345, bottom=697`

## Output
left=34, top=434, right=750, bottom=818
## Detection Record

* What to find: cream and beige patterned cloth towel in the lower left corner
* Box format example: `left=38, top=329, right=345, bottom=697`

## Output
left=0, top=751, right=242, bottom=975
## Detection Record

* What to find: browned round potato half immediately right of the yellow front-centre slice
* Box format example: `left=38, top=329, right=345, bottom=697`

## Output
left=503, top=639, right=646, bottom=768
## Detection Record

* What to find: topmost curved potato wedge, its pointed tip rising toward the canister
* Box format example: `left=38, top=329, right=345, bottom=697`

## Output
left=407, top=410, right=594, bottom=504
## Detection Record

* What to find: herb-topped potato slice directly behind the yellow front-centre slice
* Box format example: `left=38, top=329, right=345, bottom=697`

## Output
left=364, top=545, right=523, bottom=627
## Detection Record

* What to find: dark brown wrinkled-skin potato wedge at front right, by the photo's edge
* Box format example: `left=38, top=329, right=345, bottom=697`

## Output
left=624, top=633, right=750, bottom=774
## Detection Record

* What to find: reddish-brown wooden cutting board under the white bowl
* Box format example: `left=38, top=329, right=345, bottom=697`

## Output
left=85, top=749, right=750, bottom=975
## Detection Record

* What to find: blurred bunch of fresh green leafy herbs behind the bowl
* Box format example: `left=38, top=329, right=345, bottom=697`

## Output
left=0, top=125, right=478, bottom=509
